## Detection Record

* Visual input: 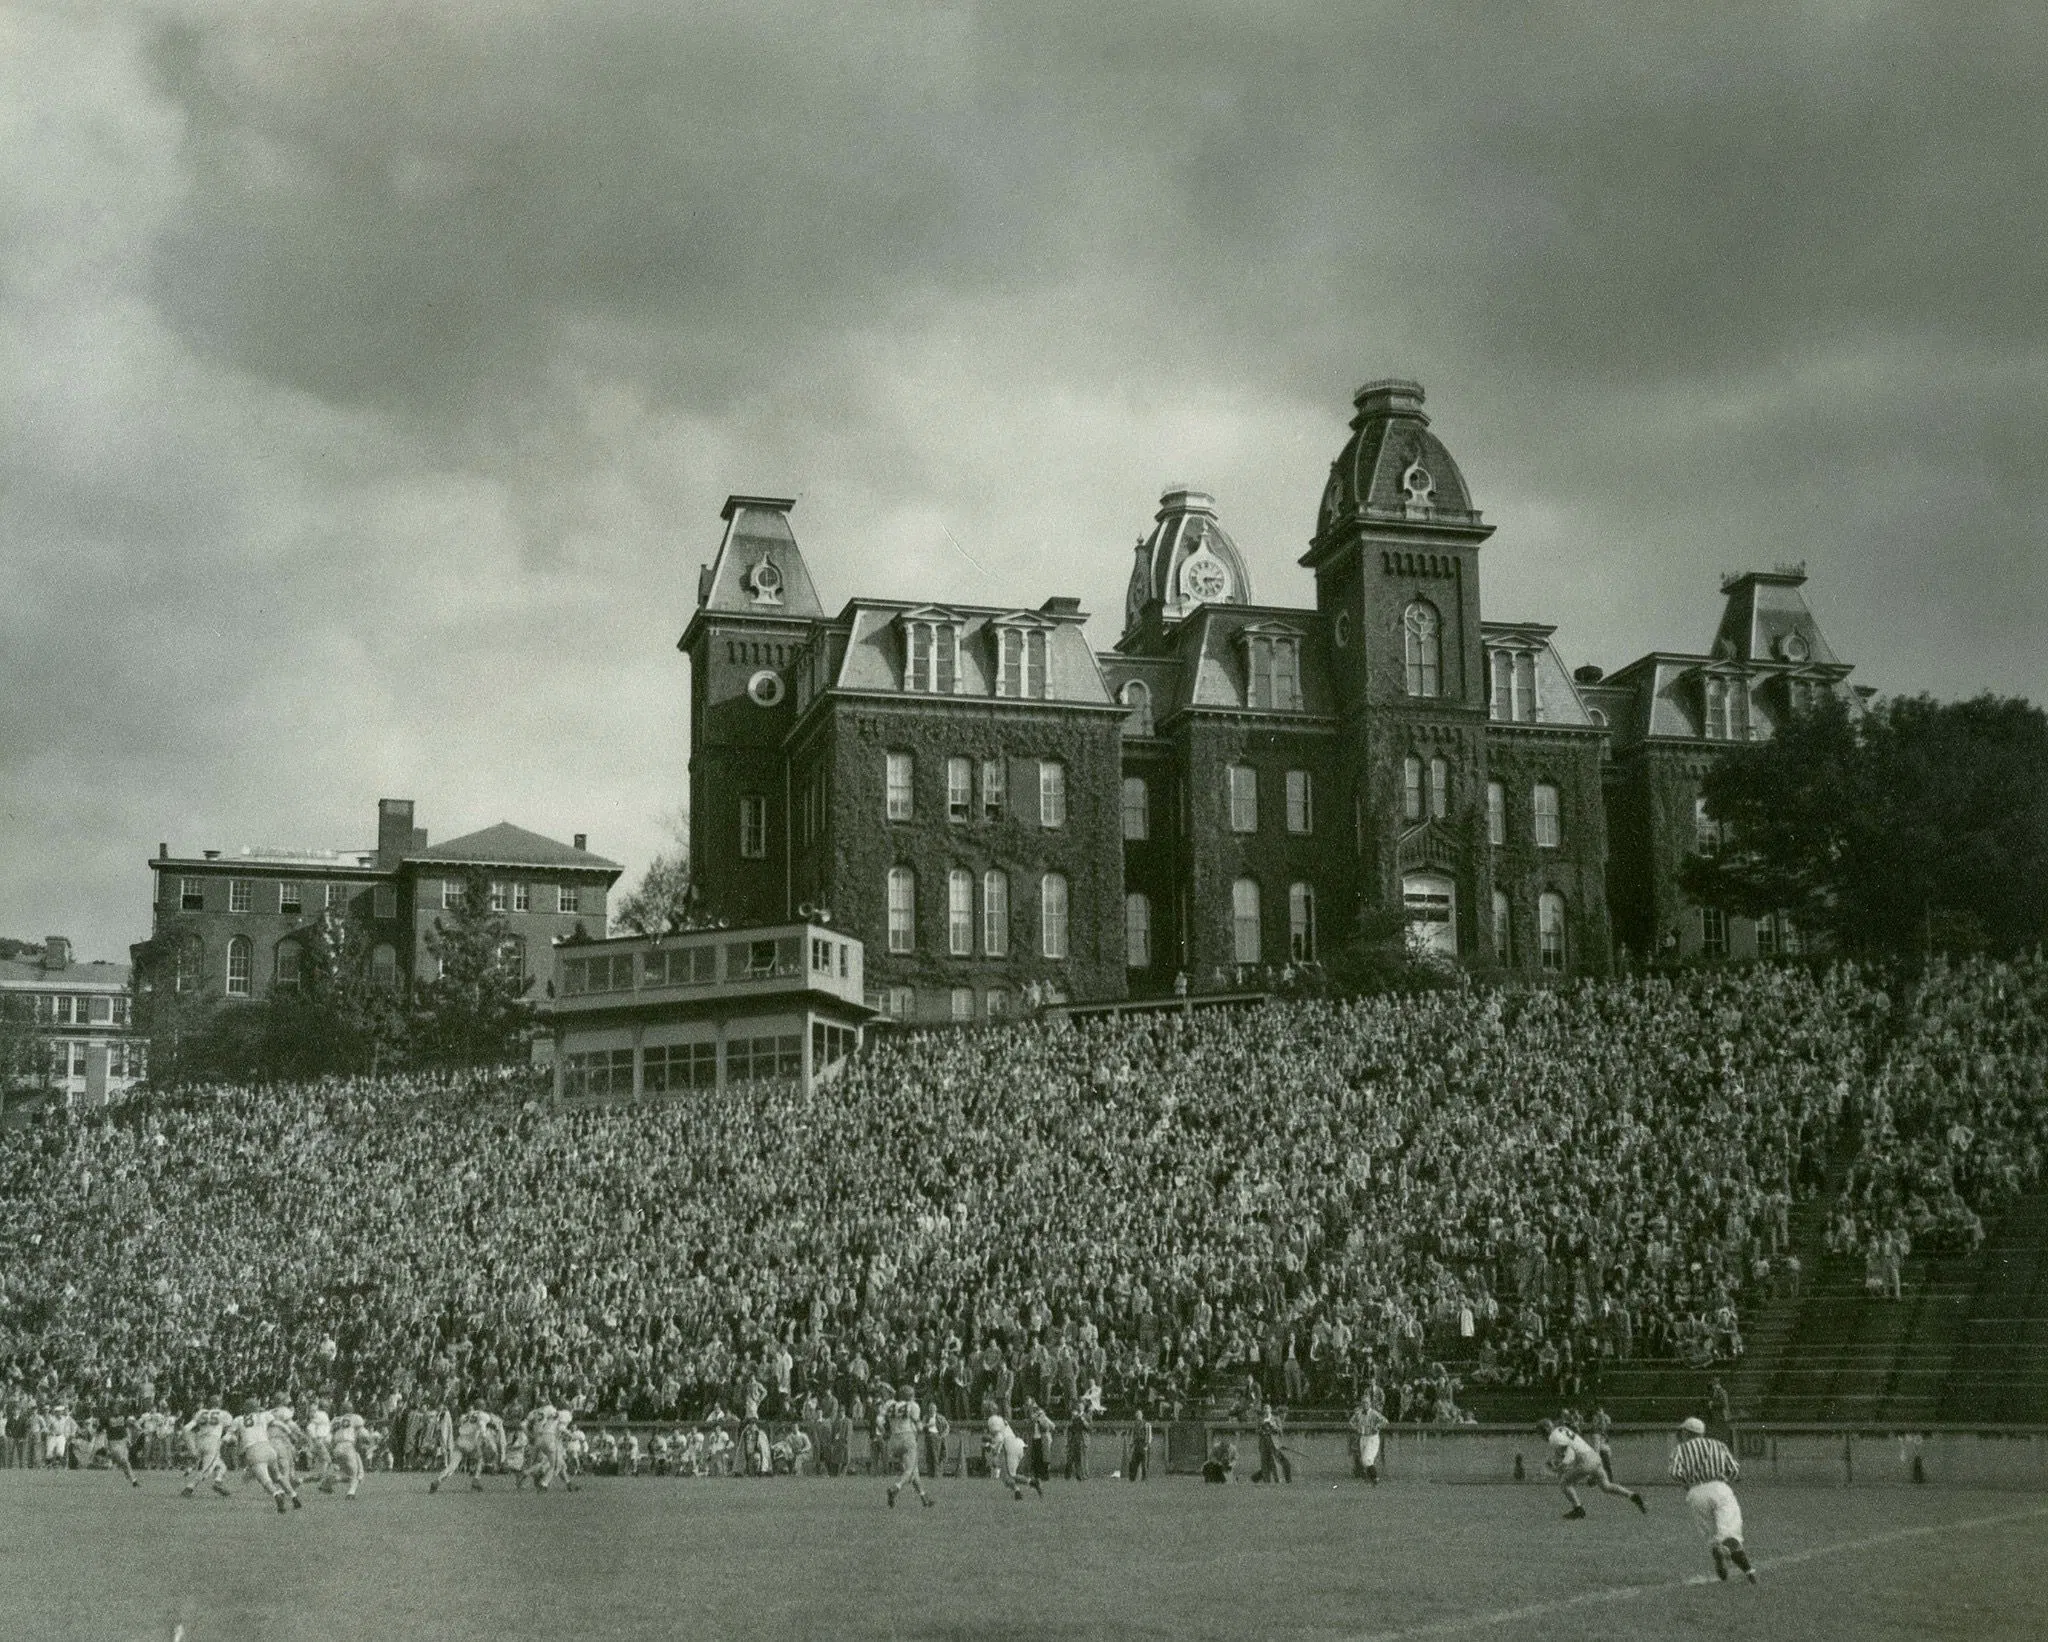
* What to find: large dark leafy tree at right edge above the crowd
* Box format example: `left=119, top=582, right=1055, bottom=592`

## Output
left=1681, top=696, right=2048, bottom=952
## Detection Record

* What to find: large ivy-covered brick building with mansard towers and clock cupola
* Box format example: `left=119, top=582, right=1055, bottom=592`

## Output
left=680, top=381, right=1847, bottom=1022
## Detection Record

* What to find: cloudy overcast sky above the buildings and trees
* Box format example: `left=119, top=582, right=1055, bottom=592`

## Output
left=0, top=0, right=2048, bottom=958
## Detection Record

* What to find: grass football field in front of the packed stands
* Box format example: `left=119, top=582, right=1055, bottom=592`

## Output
left=0, top=1470, right=2048, bottom=1642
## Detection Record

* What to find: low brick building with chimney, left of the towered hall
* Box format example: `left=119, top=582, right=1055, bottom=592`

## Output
left=150, top=798, right=623, bottom=997
